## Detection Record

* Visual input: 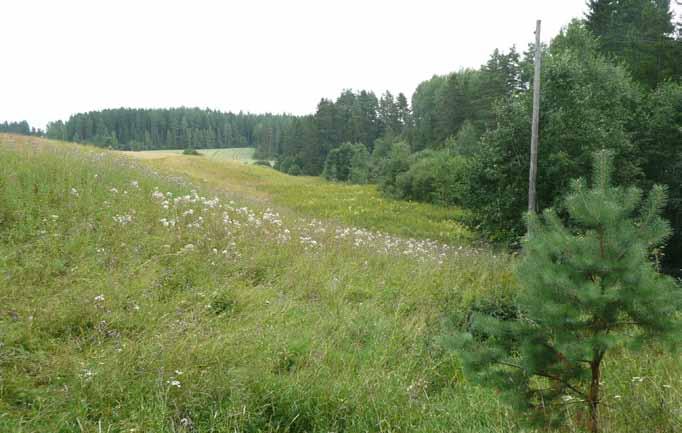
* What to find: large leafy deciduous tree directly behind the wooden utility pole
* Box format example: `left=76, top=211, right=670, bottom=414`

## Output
left=464, top=22, right=643, bottom=240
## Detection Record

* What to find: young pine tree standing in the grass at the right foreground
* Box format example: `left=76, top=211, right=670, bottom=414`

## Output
left=448, top=151, right=682, bottom=432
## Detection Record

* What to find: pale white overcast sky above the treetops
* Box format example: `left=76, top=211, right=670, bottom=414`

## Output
left=0, top=0, right=672, bottom=127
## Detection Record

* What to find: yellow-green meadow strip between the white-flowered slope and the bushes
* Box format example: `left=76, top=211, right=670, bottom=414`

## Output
left=133, top=149, right=473, bottom=243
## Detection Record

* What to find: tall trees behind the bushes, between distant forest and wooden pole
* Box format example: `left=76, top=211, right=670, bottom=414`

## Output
left=257, top=48, right=528, bottom=174
